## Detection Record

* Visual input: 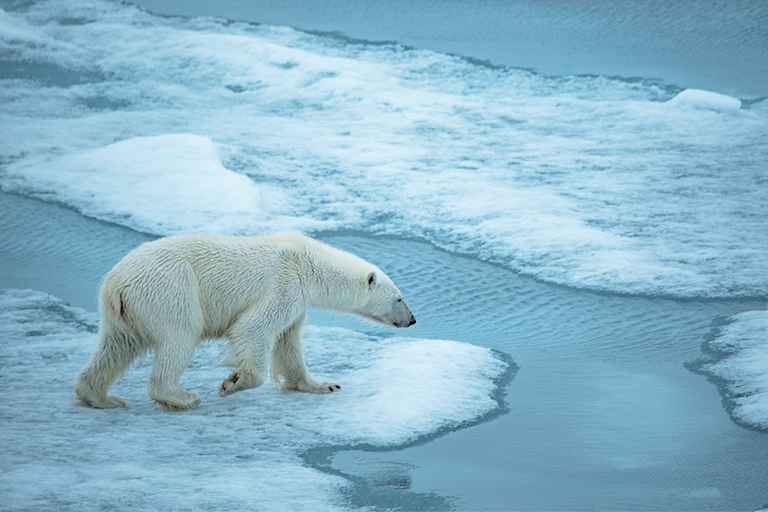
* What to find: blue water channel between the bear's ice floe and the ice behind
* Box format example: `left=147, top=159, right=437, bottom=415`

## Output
left=0, top=190, right=768, bottom=510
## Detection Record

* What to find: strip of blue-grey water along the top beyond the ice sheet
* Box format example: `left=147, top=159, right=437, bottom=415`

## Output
left=136, top=0, right=768, bottom=97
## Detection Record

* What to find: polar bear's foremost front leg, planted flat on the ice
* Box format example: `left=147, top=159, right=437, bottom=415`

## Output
left=271, top=313, right=341, bottom=394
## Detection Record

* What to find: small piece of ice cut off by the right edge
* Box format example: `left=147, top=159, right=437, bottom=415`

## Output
left=701, top=310, right=768, bottom=431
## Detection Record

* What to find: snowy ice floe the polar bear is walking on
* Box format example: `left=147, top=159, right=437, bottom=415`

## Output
left=0, top=290, right=508, bottom=510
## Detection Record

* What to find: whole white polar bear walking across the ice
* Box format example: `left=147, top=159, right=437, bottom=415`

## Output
left=74, top=233, right=416, bottom=411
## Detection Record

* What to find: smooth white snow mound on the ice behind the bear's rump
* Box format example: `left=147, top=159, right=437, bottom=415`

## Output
left=0, top=134, right=304, bottom=234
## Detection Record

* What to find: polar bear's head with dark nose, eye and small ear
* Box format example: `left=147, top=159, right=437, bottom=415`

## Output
left=355, top=268, right=416, bottom=327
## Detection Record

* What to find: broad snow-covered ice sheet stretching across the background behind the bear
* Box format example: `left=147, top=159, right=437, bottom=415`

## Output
left=0, top=0, right=768, bottom=297
